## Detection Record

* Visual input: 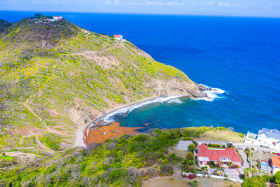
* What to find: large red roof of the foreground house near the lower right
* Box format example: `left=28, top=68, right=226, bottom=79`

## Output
left=197, top=144, right=242, bottom=162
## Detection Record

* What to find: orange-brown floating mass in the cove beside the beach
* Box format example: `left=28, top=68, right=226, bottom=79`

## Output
left=85, top=122, right=141, bottom=145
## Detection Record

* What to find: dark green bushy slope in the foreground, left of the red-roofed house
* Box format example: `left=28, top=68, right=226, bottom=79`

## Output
left=0, top=127, right=244, bottom=186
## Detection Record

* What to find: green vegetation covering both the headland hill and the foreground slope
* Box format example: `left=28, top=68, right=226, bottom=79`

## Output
left=0, top=14, right=247, bottom=186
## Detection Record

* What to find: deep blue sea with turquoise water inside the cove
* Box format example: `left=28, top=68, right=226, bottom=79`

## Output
left=0, top=12, right=280, bottom=132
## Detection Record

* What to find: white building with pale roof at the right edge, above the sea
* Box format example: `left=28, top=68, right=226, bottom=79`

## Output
left=244, top=128, right=280, bottom=150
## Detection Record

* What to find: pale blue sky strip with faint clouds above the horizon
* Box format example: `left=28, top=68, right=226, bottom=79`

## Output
left=0, top=0, right=280, bottom=17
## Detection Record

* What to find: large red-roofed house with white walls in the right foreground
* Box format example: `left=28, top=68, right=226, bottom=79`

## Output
left=197, top=144, right=242, bottom=167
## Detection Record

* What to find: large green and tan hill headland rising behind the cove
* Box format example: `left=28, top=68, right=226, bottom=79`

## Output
left=0, top=16, right=202, bottom=150
